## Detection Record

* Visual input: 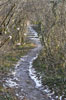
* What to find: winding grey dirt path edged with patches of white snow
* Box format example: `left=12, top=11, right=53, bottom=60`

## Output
left=3, top=26, right=53, bottom=100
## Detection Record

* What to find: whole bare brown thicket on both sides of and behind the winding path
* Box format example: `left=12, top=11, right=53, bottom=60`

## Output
left=0, top=0, right=66, bottom=99
